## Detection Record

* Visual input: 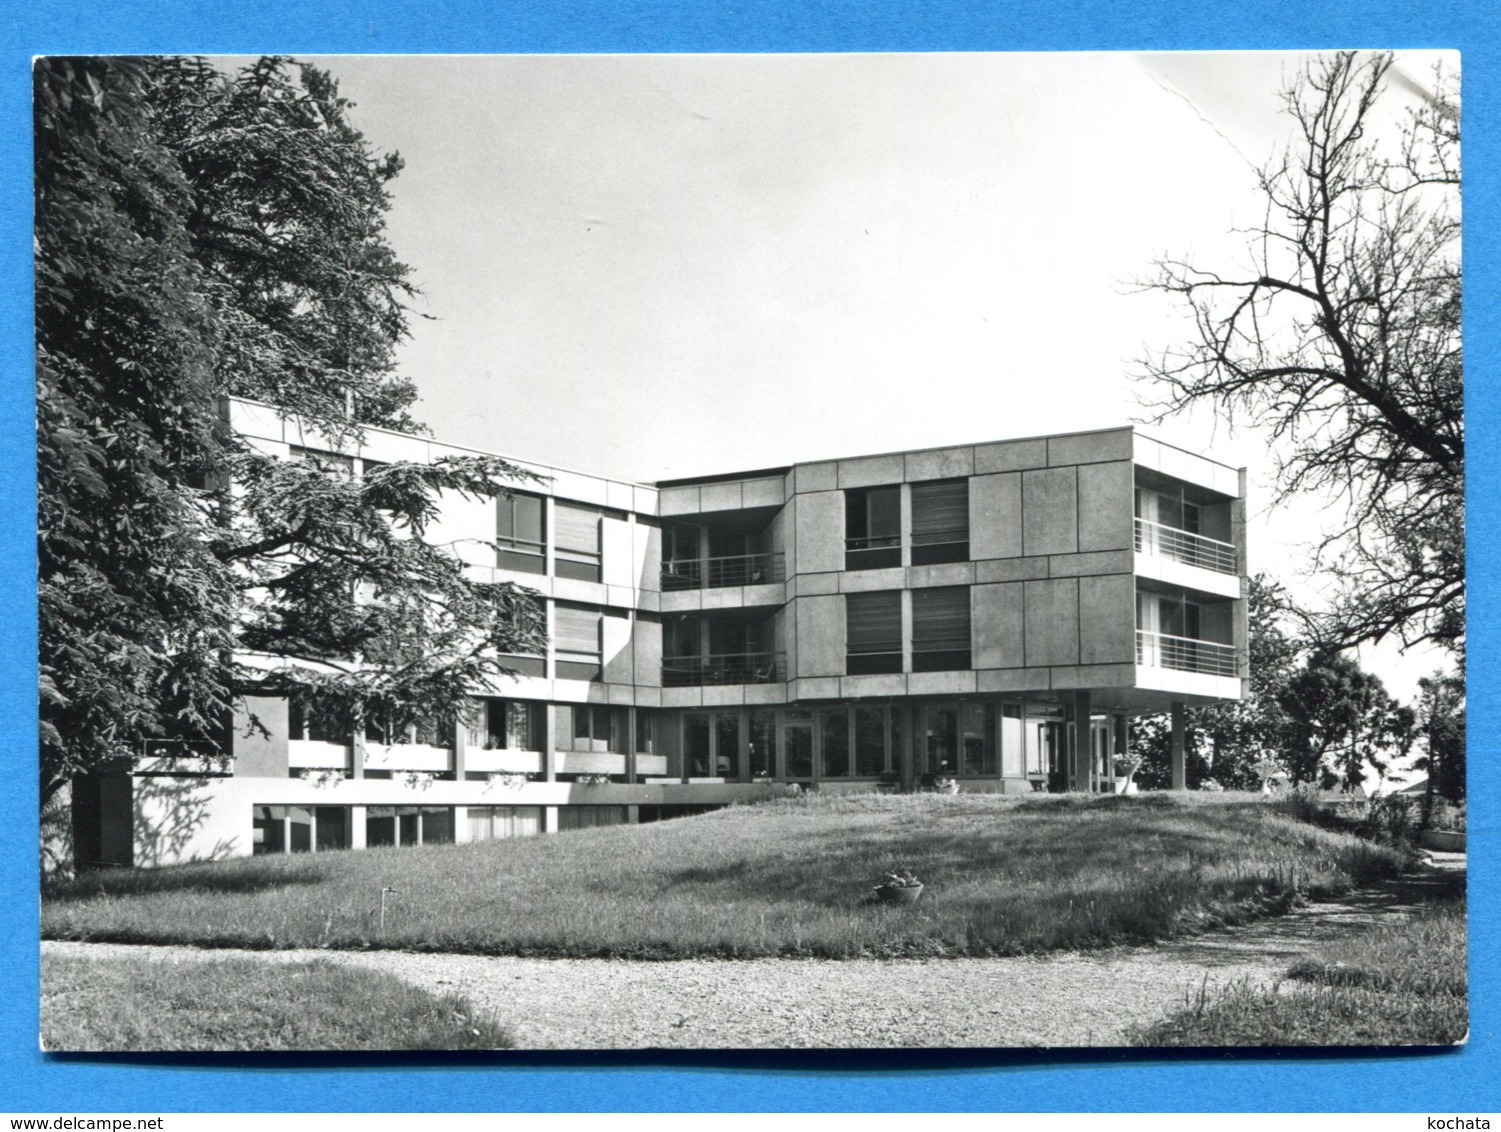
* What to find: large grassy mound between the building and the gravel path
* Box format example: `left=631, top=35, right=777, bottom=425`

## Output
left=42, top=794, right=1403, bottom=959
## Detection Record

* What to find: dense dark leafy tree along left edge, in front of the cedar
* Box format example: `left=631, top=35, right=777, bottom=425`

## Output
left=33, top=59, right=233, bottom=806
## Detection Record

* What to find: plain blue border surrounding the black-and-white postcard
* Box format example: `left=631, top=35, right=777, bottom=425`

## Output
left=0, top=0, right=1501, bottom=1112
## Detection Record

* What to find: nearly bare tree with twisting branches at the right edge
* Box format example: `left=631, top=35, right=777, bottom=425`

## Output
left=1142, top=53, right=1465, bottom=652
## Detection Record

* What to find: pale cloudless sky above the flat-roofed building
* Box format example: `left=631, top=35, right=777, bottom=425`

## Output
left=295, top=53, right=1457, bottom=695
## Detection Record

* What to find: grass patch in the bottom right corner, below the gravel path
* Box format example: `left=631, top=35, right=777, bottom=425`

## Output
left=1132, top=896, right=1468, bottom=1046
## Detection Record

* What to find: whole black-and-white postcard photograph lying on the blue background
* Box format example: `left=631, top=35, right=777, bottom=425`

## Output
left=35, top=50, right=1478, bottom=1055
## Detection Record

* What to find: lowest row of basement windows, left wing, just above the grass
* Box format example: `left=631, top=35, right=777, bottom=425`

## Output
left=252, top=806, right=626, bottom=856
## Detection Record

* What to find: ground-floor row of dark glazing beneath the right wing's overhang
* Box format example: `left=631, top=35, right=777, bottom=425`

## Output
left=683, top=703, right=1045, bottom=781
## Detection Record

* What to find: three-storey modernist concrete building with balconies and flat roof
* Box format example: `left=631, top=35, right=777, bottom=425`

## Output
left=75, top=402, right=1247, bottom=865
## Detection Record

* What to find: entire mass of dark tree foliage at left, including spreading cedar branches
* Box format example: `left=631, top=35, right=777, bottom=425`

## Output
left=35, top=59, right=542, bottom=803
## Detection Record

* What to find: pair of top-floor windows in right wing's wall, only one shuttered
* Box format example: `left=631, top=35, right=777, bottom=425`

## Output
left=845, top=479, right=970, bottom=571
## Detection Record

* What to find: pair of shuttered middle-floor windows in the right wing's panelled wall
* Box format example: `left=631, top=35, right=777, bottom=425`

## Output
left=845, top=586, right=970, bottom=676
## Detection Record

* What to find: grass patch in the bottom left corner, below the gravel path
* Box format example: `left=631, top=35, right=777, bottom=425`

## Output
left=42, top=955, right=510, bottom=1052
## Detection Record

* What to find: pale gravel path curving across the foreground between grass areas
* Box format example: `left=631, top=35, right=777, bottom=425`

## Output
left=42, top=854, right=1463, bottom=1049
